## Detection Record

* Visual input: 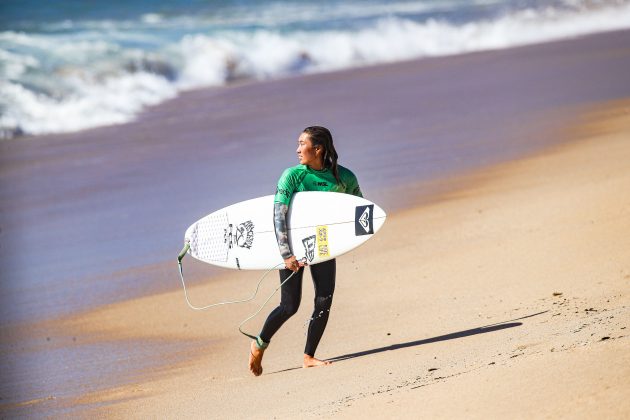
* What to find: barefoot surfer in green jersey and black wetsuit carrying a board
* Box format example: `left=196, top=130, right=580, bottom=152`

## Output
left=249, top=126, right=362, bottom=376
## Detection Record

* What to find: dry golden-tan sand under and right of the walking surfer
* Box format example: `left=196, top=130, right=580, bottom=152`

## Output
left=4, top=98, right=630, bottom=418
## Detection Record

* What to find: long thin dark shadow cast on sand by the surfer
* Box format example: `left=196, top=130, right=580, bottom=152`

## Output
left=269, top=311, right=549, bottom=374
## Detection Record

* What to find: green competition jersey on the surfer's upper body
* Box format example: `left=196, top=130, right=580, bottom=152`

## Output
left=274, top=165, right=363, bottom=205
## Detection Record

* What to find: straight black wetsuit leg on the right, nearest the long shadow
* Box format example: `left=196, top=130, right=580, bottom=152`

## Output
left=304, top=259, right=337, bottom=357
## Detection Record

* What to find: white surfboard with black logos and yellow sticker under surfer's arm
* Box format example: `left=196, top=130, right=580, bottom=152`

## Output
left=180, top=191, right=387, bottom=270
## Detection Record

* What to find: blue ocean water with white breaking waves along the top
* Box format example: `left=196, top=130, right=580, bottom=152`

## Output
left=0, top=0, right=630, bottom=138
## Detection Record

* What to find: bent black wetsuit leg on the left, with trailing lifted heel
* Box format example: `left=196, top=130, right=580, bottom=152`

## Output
left=260, top=267, right=304, bottom=343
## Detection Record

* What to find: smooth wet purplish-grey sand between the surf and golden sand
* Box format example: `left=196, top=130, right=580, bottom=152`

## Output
left=0, top=31, right=630, bottom=323
